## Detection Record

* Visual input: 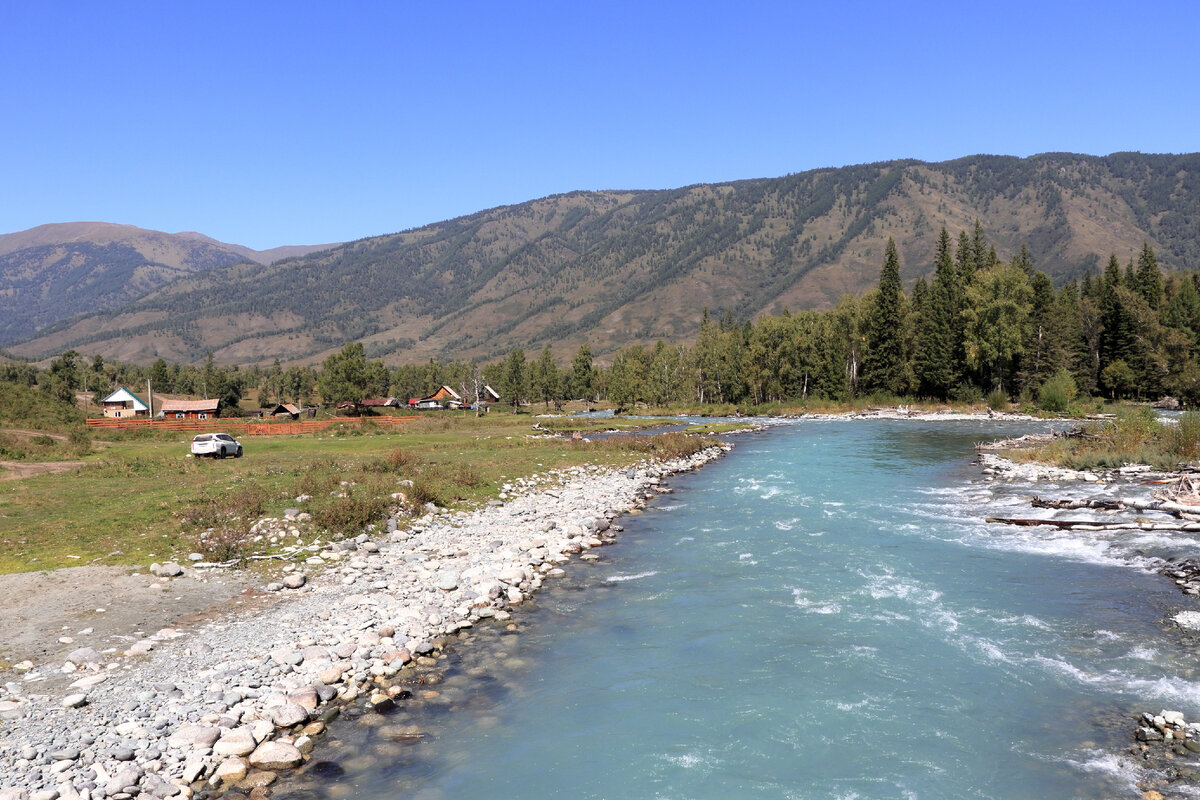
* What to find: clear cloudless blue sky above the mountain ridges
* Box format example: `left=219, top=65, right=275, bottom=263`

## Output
left=0, top=0, right=1200, bottom=249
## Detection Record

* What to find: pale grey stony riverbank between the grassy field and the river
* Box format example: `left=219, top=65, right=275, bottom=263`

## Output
left=0, top=446, right=722, bottom=800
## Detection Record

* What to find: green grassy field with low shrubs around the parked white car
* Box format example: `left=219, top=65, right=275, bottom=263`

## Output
left=0, top=413, right=710, bottom=573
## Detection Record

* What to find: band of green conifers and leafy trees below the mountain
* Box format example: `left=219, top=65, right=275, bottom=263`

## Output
left=9, top=221, right=1200, bottom=417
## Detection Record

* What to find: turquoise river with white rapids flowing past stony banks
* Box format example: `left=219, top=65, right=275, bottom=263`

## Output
left=276, top=421, right=1200, bottom=800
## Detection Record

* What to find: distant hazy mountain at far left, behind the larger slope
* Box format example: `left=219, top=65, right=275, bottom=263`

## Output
left=0, top=222, right=340, bottom=343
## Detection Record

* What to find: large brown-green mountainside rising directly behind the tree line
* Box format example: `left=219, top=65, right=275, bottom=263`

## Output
left=10, top=154, right=1200, bottom=363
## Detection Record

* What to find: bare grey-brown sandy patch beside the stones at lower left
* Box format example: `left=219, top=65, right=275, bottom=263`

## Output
left=0, top=566, right=274, bottom=688
